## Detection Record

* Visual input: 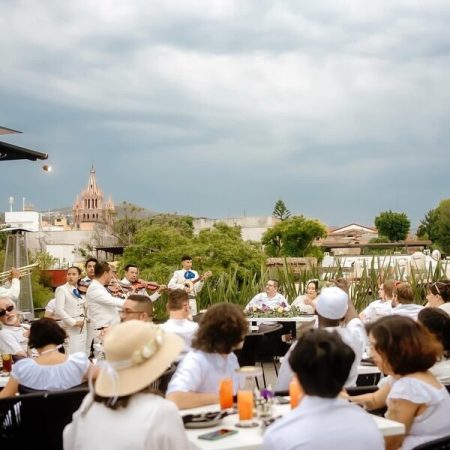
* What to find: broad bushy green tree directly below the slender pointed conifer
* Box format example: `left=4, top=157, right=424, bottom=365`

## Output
left=262, top=216, right=327, bottom=256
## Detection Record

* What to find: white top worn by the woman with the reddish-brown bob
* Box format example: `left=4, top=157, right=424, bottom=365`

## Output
left=386, top=377, right=450, bottom=450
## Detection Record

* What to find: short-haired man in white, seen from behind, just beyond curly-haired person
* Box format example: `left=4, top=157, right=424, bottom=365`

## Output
left=161, top=289, right=198, bottom=360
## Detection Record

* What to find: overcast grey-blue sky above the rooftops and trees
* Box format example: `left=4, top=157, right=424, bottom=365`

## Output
left=0, top=0, right=450, bottom=226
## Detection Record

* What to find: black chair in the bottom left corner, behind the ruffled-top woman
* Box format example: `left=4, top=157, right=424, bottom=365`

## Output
left=0, top=388, right=89, bottom=450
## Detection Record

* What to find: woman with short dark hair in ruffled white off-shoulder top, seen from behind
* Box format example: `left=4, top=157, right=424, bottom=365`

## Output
left=0, top=317, right=90, bottom=398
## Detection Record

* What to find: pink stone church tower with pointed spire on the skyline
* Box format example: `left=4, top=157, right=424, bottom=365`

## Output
left=73, top=165, right=114, bottom=230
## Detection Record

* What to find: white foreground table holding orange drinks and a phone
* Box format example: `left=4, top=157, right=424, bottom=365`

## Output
left=180, top=404, right=405, bottom=450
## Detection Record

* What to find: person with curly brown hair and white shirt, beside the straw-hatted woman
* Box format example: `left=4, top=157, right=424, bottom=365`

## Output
left=166, top=303, right=248, bottom=409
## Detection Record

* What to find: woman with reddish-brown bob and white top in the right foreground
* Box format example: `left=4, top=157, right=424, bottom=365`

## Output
left=350, top=315, right=450, bottom=450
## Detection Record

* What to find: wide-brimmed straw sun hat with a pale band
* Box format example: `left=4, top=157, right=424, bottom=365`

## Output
left=95, top=320, right=184, bottom=397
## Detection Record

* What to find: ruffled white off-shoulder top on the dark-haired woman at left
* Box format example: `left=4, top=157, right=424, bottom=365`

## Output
left=11, top=352, right=89, bottom=391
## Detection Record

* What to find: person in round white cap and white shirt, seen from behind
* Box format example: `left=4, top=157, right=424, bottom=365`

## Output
left=275, top=286, right=367, bottom=391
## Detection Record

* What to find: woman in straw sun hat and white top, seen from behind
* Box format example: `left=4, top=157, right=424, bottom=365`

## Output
left=64, top=320, right=189, bottom=450
